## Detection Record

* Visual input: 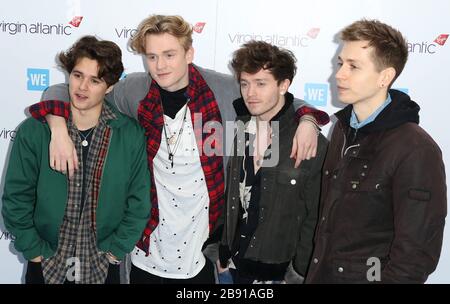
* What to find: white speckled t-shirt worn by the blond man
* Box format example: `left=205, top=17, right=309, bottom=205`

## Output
left=131, top=105, right=209, bottom=279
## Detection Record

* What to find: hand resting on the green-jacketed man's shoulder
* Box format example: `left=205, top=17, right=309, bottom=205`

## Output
left=46, top=114, right=79, bottom=179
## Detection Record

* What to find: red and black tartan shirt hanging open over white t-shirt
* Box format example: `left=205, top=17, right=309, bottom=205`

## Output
left=137, top=65, right=225, bottom=253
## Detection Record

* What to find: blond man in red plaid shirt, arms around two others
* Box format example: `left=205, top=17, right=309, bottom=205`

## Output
left=31, top=15, right=329, bottom=283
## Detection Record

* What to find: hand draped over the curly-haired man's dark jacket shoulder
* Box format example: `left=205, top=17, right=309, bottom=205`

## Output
left=290, top=119, right=318, bottom=168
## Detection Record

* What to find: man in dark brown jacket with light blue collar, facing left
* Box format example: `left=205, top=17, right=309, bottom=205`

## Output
left=307, top=20, right=447, bottom=283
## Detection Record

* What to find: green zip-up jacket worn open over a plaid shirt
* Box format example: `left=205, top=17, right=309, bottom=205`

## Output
left=2, top=102, right=151, bottom=260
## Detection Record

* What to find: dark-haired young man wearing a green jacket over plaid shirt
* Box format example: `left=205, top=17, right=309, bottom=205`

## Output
left=2, top=36, right=151, bottom=284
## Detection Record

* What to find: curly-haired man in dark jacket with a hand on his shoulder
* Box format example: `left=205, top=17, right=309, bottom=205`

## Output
left=218, top=41, right=327, bottom=283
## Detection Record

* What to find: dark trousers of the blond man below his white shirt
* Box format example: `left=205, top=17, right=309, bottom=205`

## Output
left=130, top=259, right=216, bottom=284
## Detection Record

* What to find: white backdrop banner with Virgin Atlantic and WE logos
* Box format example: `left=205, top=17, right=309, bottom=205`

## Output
left=0, top=0, right=450, bottom=283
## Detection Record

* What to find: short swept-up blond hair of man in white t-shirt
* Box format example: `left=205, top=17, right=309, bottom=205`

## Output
left=130, top=15, right=192, bottom=54
